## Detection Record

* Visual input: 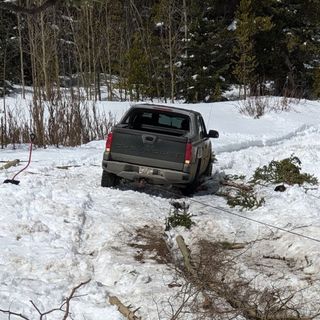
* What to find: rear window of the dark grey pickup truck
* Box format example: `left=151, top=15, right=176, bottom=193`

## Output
left=122, top=109, right=190, bottom=136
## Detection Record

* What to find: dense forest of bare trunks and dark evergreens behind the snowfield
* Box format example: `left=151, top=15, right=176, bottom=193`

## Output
left=0, top=0, right=320, bottom=103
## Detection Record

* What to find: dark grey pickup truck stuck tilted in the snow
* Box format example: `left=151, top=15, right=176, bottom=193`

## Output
left=101, top=104, right=219, bottom=193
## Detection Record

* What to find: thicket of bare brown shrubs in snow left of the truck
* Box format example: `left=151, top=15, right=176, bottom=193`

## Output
left=1, top=97, right=115, bottom=147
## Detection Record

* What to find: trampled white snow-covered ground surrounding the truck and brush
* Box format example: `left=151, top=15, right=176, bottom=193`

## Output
left=0, top=100, right=320, bottom=320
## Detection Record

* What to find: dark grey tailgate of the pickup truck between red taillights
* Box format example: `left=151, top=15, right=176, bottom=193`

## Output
left=111, top=127, right=187, bottom=171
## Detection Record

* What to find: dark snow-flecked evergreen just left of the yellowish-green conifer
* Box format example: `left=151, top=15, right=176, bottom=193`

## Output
left=183, top=0, right=233, bottom=102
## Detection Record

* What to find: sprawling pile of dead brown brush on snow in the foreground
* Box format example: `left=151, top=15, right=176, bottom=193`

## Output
left=125, top=225, right=320, bottom=320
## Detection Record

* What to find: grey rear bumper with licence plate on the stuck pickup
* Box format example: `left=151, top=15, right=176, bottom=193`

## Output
left=102, top=160, right=191, bottom=185
